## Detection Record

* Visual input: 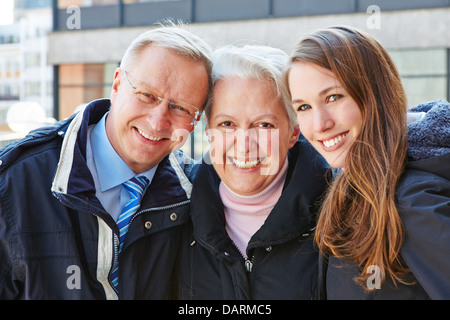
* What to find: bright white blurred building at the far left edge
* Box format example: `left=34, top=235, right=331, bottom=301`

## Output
left=0, top=0, right=54, bottom=146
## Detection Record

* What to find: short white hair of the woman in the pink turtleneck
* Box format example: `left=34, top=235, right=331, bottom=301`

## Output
left=205, top=44, right=298, bottom=129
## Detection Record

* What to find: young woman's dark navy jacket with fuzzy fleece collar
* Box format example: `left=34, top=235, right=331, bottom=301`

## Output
left=320, top=101, right=450, bottom=300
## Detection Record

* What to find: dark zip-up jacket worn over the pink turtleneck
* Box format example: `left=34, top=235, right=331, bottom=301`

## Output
left=180, top=139, right=327, bottom=300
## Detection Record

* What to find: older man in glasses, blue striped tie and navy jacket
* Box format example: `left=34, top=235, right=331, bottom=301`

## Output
left=0, top=26, right=211, bottom=299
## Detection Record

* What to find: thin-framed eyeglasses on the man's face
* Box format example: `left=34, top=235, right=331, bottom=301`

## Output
left=123, top=70, right=201, bottom=125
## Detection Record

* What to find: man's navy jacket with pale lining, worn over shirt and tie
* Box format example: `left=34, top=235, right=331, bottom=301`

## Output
left=0, top=99, right=192, bottom=299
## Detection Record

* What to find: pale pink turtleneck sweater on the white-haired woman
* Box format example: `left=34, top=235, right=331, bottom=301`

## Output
left=219, top=158, right=288, bottom=258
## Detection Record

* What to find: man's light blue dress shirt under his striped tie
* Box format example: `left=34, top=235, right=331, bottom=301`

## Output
left=86, top=113, right=158, bottom=221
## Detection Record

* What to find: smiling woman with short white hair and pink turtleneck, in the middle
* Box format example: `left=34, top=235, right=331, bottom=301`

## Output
left=181, top=46, right=327, bottom=299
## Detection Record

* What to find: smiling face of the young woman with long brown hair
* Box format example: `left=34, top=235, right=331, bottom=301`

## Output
left=289, top=62, right=362, bottom=168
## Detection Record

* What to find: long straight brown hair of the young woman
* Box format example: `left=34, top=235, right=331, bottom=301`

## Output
left=291, top=26, right=407, bottom=285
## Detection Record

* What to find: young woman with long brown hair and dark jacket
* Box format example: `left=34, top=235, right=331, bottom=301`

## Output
left=285, top=26, right=450, bottom=299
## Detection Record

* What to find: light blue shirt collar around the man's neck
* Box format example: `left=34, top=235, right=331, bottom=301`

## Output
left=91, top=113, right=158, bottom=192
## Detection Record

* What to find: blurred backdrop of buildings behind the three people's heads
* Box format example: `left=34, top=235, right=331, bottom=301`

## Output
left=0, top=0, right=450, bottom=159
